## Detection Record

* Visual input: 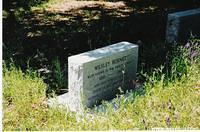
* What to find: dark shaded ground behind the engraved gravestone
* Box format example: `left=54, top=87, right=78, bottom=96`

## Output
left=3, top=0, right=200, bottom=93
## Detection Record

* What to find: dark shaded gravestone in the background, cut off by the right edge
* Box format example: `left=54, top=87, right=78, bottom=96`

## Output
left=166, top=8, right=200, bottom=43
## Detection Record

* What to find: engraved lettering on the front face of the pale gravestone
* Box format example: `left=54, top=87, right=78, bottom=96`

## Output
left=84, top=54, right=133, bottom=100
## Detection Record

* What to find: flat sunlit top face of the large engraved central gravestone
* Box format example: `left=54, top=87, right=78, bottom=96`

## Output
left=68, top=41, right=138, bottom=64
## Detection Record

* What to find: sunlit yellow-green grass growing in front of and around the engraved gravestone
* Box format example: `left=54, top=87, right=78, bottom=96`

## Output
left=3, top=40, right=200, bottom=130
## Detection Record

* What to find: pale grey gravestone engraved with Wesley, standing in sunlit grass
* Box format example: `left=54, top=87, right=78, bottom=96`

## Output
left=47, top=42, right=138, bottom=111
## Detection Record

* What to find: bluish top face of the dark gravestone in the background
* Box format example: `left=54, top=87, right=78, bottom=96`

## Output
left=169, top=8, right=200, bottom=17
